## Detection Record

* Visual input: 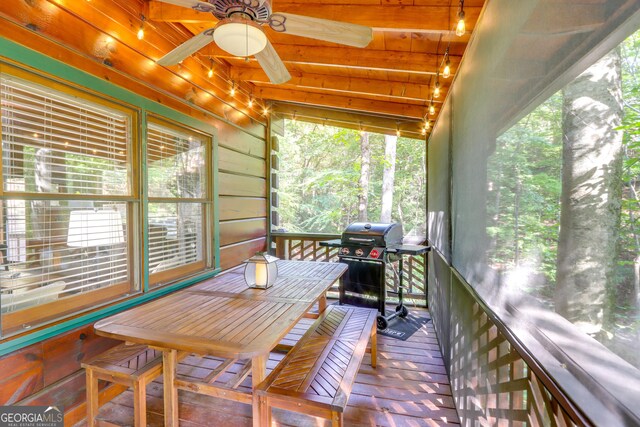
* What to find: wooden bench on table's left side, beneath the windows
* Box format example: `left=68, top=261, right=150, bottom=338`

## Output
left=82, top=344, right=162, bottom=427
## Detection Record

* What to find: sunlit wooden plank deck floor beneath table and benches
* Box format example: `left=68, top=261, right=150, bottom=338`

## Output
left=82, top=308, right=459, bottom=427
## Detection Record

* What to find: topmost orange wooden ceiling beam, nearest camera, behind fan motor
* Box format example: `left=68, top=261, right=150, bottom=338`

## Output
left=147, top=1, right=481, bottom=33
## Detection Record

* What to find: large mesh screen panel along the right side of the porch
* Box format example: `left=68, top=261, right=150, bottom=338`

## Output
left=429, top=0, right=640, bottom=425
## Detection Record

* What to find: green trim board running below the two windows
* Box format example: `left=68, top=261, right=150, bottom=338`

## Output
left=0, top=268, right=221, bottom=356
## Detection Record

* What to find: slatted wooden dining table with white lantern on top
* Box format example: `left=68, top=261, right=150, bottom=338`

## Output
left=95, top=260, right=347, bottom=426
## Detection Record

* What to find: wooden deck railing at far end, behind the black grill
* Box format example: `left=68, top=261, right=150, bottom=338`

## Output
left=271, top=232, right=427, bottom=305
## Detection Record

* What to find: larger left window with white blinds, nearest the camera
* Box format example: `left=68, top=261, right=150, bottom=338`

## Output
left=0, top=73, right=135, bottom=336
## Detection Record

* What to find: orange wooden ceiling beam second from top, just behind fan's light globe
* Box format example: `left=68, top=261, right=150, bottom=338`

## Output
left=204, top=44, right=460, bottom=75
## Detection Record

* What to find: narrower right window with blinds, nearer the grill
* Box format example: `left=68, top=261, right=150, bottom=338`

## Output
left=147, top=120, right=211, bottom=285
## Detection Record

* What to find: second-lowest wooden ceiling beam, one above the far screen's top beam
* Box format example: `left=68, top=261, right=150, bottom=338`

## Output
left=254, top=87, right=427, bottom=120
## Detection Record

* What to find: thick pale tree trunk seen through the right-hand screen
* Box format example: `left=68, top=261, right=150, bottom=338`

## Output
left=555, top=51, right=622, bottom=333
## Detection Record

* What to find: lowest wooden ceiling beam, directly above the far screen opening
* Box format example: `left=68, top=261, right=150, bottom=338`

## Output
left=273, top=102, right=425, bottom=139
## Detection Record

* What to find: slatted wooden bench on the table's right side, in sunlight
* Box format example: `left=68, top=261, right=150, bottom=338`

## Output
left=253, top=306, right=378, bottom=426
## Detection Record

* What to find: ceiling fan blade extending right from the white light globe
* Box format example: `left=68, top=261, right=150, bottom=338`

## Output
left=271, top=13, right=373, bottom=47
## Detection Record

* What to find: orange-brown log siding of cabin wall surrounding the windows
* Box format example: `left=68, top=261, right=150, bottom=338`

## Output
left=0, top=0, right=267, bottom=425
